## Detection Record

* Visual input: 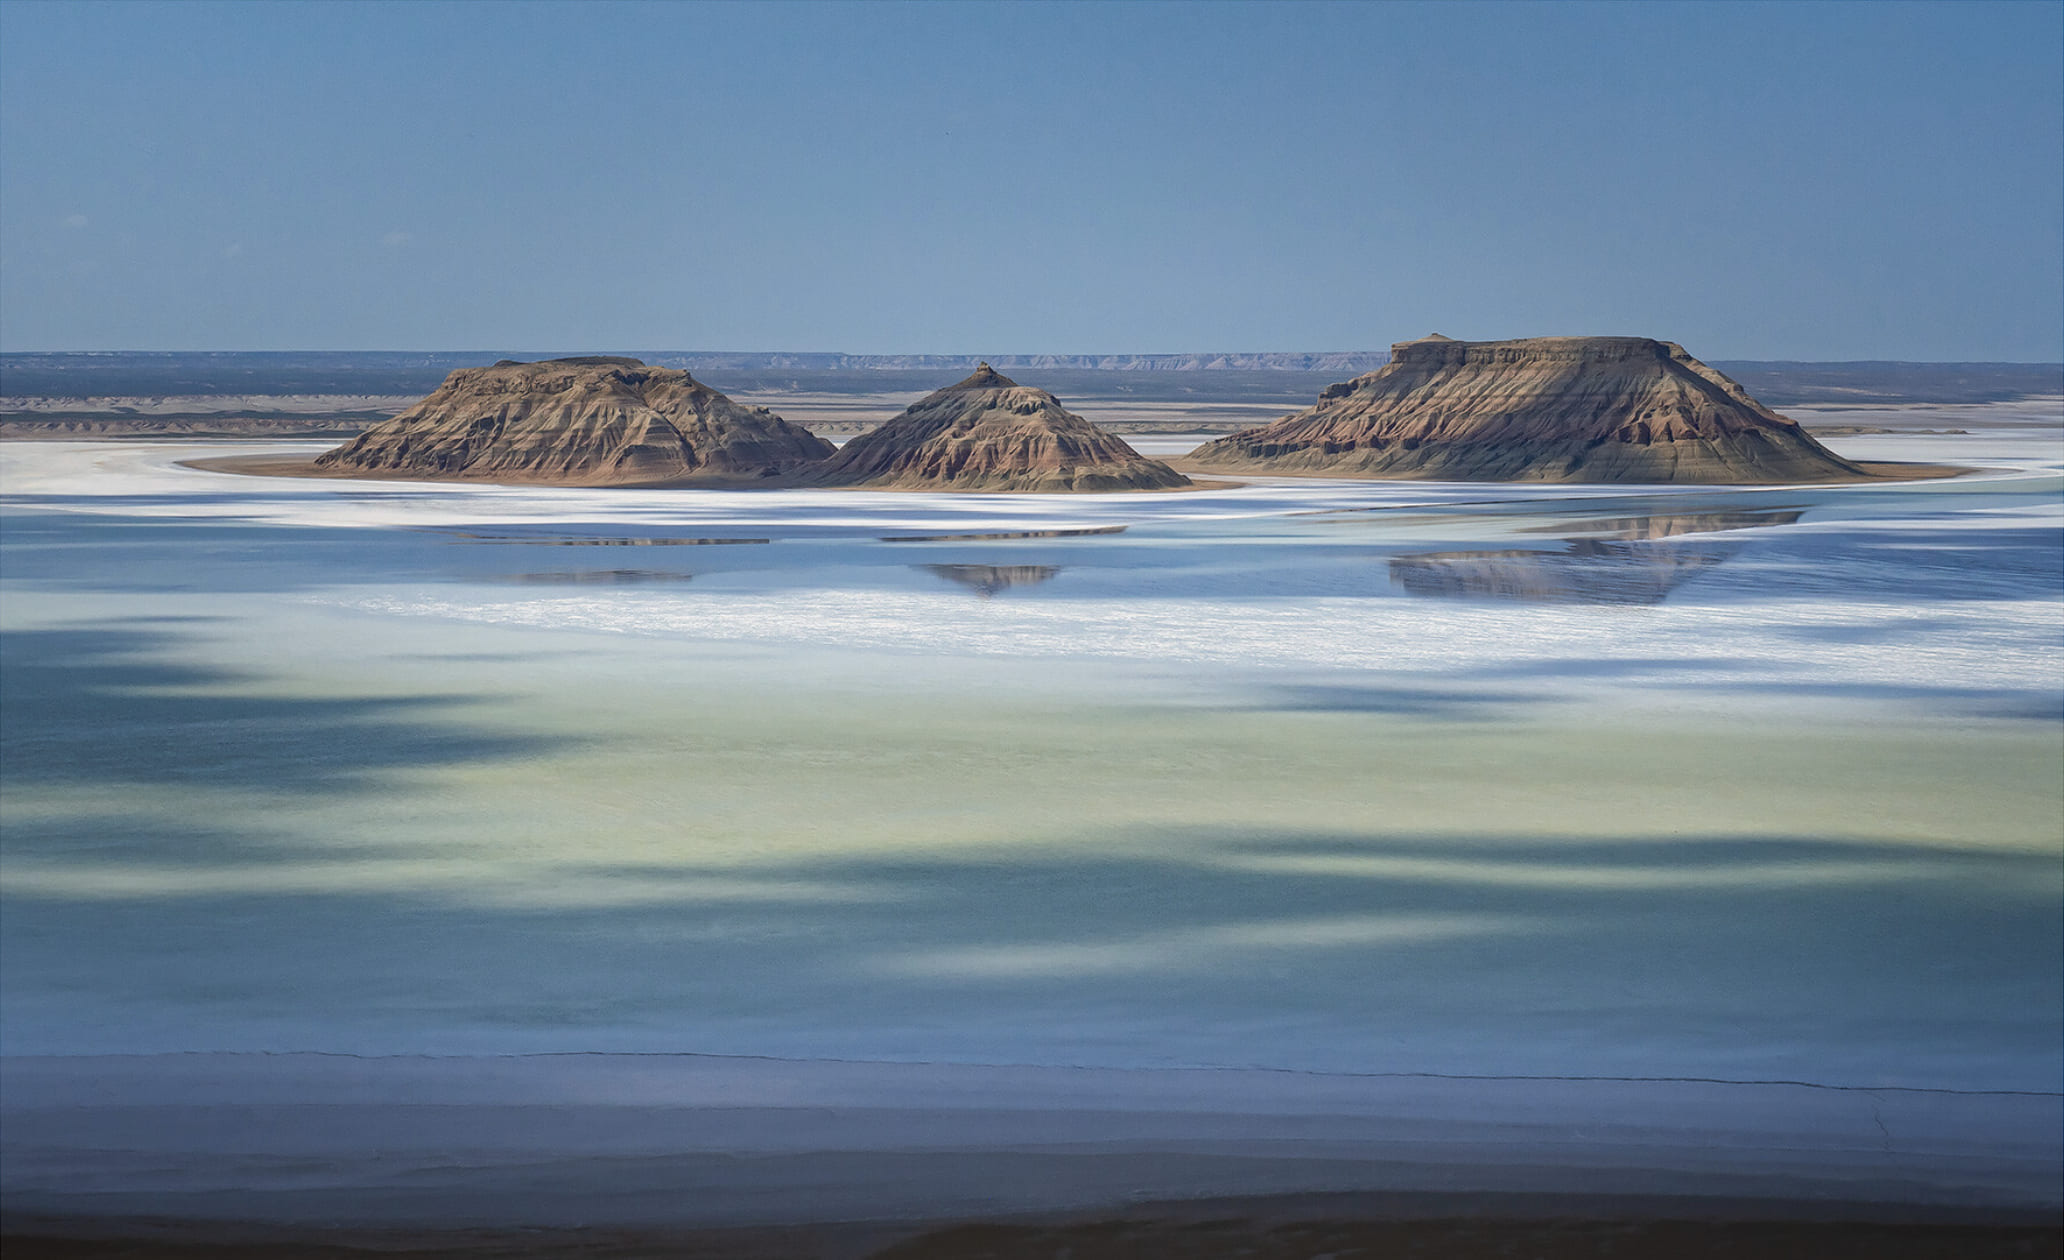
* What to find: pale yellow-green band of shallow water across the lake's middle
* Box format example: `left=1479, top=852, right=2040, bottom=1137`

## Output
left=8, top=603, right=2064, bottom=905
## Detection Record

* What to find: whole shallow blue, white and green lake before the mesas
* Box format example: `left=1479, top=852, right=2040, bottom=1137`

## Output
left=0, top=423, right=2064, bottom=1091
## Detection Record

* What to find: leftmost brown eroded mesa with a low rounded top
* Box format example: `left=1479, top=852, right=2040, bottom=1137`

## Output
left=316, top=355, right=834, bottom=485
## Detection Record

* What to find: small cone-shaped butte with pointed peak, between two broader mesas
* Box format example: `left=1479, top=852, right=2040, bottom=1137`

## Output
left=805, top=364, right=1189, bottom=492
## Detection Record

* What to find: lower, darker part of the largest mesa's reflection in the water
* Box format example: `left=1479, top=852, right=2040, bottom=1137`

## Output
left=1391, top=539, right=1734, bottom=603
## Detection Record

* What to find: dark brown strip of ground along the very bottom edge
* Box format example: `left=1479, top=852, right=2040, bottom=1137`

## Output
left=0, top=1194, right=2064, bottom=1260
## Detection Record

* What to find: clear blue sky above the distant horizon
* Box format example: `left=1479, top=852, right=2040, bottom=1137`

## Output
left=0, top=0, right=2064, bottom=361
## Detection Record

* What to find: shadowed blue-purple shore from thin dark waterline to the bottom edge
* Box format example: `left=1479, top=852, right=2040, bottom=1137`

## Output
left=0, top=1053, right=2064, bottom=1260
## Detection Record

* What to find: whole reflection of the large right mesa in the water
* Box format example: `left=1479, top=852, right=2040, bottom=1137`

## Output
left=1391, top=508, right=1802, bottom=603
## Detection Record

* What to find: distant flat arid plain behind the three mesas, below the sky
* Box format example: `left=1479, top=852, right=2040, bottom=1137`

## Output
left=0, top=351, right=2064, bottom=440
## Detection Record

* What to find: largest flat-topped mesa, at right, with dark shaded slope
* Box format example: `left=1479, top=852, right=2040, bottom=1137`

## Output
left=1189, top=333, right=1870, bottom=483
